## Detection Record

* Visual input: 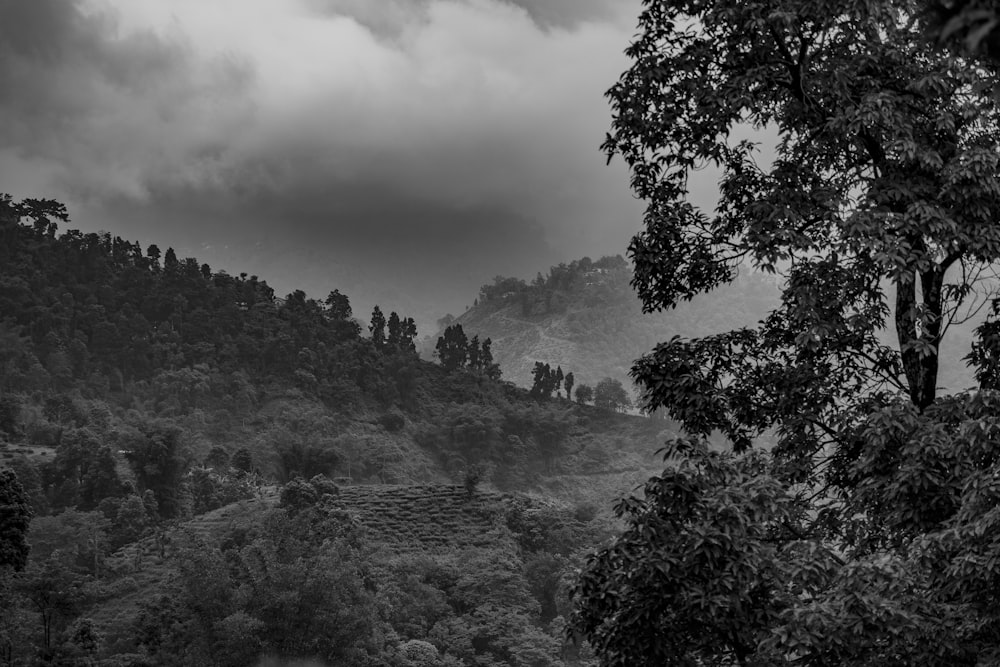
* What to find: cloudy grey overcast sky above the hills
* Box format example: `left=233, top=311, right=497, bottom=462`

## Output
left=0, top=0, right=672, bottom=334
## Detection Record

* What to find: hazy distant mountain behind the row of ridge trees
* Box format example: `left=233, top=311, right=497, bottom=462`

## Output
left=421, top=255, right=778, bottom=396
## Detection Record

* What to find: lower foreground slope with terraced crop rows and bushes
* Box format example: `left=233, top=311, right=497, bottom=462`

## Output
left=33, top=481, right=609, bottom=667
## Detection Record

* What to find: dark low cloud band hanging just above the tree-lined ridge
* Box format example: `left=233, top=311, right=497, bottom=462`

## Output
left=94, top=183, right=553, bottom=334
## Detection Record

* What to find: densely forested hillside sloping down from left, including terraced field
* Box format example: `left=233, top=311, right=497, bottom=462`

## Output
left=0, top=196, right=670, bottom=666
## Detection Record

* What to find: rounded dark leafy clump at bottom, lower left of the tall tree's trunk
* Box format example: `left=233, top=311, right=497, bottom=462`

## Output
left=576, top=445, right=835, bottom=665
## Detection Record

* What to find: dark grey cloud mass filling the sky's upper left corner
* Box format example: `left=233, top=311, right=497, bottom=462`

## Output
left=0, top=0, right=252, bottom=201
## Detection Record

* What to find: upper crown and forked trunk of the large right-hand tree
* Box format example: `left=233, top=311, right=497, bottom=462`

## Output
left=605, top=0, right=1000, bottom=418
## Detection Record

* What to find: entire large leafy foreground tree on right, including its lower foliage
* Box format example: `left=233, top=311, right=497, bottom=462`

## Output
left=574, top=0, right=1000, bottom=665
